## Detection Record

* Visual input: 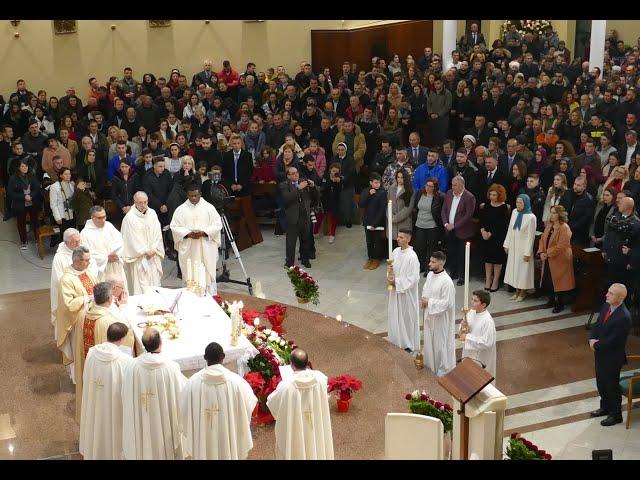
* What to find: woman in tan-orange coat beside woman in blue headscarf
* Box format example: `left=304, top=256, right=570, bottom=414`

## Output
left=538, top=205, right=576, bottom=313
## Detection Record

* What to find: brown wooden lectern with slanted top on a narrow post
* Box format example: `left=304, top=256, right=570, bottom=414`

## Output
left=438, top=358, right=493, bottom=460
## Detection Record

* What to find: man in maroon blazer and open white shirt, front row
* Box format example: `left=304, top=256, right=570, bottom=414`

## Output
left=441, top=175, right=476, bottom=285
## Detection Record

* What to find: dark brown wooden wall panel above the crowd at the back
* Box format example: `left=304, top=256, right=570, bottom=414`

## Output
left=311, top=20, right=433, bottom=77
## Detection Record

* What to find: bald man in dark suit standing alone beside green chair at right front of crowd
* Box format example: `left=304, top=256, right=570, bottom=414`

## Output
left=589, top=283, right=631, bottom=427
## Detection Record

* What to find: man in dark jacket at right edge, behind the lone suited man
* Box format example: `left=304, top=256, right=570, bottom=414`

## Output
left=602, top=197, right=640, bottom=288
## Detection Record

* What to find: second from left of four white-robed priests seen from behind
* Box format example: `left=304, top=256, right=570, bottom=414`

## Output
left=122, top=328, right=187, bottom=460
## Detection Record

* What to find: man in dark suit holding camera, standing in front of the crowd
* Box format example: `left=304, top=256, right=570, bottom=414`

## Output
left=278, top=167, right=311, bottom=268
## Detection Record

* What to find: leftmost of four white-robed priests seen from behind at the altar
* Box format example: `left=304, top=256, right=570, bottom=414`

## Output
left=80, top=322, right=133, bottom=460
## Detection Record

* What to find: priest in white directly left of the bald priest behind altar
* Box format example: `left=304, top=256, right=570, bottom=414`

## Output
left=80, top=205, right=126, bottom=285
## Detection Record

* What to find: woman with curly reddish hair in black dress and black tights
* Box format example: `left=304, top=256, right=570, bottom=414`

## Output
left=480, top=183, right=510, bottom=292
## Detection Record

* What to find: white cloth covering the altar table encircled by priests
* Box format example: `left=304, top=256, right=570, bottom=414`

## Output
left=124, top=287, right=258, bottom=375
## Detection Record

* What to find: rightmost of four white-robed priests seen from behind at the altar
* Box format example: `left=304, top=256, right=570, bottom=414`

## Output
left=267, top=348, right=333, bottom=460
